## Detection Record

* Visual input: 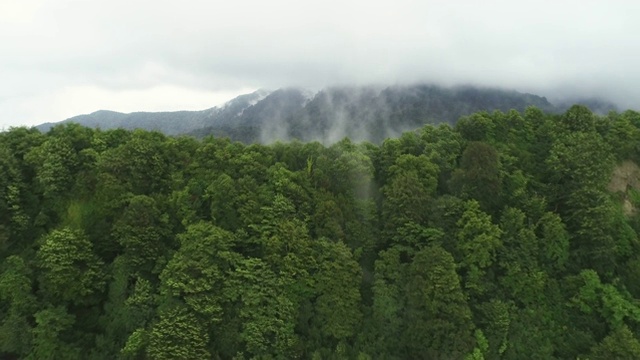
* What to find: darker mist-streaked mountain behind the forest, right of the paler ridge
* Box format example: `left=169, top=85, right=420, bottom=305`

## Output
left=190, top=85, right=557, bottom=143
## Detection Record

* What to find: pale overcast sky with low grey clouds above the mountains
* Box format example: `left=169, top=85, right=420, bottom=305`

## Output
left=0, top=0, right=640, bottom=129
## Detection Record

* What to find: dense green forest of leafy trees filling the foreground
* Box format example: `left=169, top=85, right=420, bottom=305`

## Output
left=0, top=105, right=640, bottom=360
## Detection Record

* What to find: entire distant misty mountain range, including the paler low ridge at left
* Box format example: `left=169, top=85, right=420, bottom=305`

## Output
left=37, top=85, right=562, bottom=143
